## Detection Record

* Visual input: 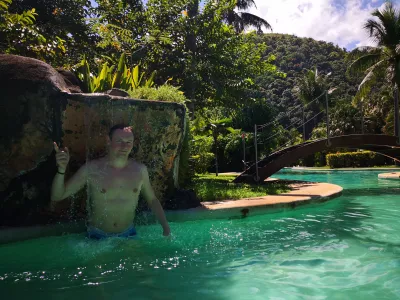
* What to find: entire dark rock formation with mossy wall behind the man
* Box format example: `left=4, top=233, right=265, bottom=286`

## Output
left=0, top=54, right=186, bottom=226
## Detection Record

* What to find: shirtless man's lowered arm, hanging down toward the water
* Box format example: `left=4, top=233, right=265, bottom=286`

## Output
left=142, top=166, right=171, bottom=236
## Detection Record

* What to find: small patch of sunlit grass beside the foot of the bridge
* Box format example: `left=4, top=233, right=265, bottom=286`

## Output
left=192, top=174, right=289, bottom=201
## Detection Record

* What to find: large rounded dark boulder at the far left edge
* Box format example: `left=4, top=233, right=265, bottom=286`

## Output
left=0, top=54, right=69, bottom=225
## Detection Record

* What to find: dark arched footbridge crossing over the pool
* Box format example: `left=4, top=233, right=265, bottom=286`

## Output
left=234, top=134, right=400, bottom=182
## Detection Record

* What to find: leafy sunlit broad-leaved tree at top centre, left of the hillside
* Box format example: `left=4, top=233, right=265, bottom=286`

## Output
left=142, top=0, right=279, bottom=109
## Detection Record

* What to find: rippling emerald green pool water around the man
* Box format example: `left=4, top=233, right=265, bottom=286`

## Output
left=0, top=171, right=400, bottom=300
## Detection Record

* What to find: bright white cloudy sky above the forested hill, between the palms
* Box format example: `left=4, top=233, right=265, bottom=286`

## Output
left=249, top=0, right=400, bottom=50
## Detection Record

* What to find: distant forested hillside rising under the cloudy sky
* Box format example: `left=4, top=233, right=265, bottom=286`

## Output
left=257, top=34, right=357, bottom=137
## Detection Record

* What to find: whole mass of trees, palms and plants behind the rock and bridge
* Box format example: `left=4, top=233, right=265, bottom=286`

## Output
left=0, top=0, right=400, bottom=174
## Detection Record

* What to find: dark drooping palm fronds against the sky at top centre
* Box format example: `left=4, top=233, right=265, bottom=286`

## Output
left=225, top=0, right=272, bottom=33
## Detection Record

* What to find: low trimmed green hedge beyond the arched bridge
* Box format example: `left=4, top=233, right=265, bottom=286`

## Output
left=326, top=151, right=386, bottom=168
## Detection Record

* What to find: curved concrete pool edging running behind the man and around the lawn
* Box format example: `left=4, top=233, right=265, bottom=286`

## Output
left=0, top=179, right=343, bottom=244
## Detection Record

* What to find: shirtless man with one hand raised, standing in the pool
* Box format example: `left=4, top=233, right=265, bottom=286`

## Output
left=51, top=124, right=170, bottom=239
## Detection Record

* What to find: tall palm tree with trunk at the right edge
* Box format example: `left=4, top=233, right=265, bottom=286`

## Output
left=348, top=2, right=400, bottom=136
